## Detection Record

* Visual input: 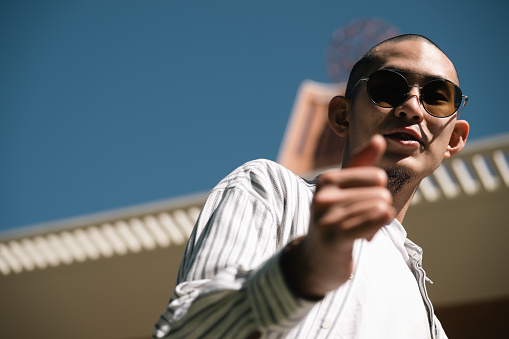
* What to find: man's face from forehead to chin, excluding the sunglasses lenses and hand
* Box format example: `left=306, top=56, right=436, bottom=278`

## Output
left=346, top=40, right=468, bottom=183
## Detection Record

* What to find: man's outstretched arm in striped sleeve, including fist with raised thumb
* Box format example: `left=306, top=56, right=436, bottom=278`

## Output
left=154, top=138, right=394, bottom=338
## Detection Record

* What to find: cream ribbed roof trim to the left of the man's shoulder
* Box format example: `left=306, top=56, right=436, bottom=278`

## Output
left=0, top=195, right=206, bottom=275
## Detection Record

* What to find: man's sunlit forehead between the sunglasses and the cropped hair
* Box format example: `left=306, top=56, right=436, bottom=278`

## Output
left=373, top=39, right=459, bottom=86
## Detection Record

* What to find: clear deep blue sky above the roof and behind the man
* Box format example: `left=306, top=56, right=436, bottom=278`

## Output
left=0, top=0, right=509, bottom=230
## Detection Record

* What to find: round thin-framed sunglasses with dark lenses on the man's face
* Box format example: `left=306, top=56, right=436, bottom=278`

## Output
left=347, top=69, right=468, bottom=118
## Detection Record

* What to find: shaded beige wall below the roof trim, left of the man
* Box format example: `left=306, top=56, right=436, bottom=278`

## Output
left=0, top=246, right=184, bottom=339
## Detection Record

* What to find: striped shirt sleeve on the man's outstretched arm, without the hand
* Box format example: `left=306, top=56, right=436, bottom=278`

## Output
left=153, top=168, right=315, bottom=338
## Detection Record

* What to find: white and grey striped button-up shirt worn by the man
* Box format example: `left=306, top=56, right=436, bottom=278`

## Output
left=153, top=160, right=447, bottom=339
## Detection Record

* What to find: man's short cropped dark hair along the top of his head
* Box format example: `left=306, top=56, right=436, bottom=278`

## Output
left=345, top=34, right=457, bottom=98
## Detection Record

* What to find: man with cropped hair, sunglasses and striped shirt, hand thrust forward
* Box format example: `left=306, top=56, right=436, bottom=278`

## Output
left=154, top=35, right=469, bottom=338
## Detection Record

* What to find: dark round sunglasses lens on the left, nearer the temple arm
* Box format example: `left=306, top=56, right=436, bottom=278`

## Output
left=368, top=70, right=408, bottom=108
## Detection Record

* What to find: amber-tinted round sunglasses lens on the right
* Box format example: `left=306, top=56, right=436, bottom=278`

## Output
left=422, top=80, right=461, bottom=117
